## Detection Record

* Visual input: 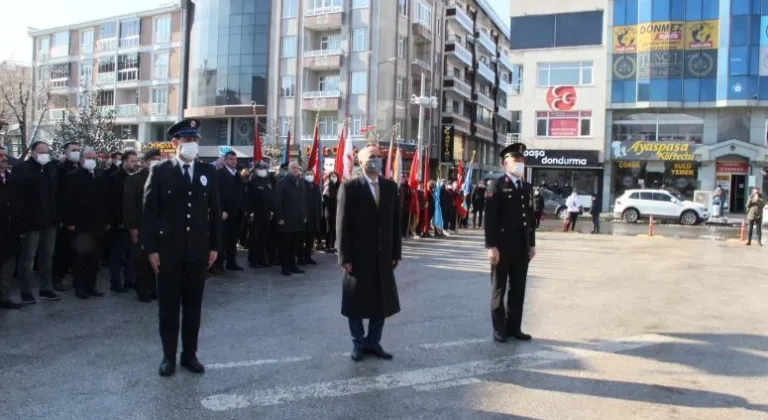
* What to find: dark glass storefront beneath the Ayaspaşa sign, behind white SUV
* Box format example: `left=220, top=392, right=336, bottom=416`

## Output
left=611, top=161, right=699, bottom=200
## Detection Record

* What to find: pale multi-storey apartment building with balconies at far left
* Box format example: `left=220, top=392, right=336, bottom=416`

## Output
left=29, top=4, right=185, bottom=145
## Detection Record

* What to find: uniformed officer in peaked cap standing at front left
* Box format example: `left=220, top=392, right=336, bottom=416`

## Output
left=140, top=119, right=221, bottom=376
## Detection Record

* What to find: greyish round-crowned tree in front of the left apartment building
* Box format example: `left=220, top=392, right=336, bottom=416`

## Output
left=54, top=90, right=125, bottom=156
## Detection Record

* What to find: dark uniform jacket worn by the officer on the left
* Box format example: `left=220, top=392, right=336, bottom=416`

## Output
left=140, top=158, right=222, bottom=264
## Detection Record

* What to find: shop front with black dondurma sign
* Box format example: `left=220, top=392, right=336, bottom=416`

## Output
left=525, top=149, right=603, bottom=196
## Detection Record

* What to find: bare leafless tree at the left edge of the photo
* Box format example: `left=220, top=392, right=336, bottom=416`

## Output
left=0, top=61, right=51, bottom=158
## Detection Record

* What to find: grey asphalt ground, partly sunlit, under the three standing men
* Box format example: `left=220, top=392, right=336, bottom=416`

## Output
left=0, top=231, right=768, bottom=420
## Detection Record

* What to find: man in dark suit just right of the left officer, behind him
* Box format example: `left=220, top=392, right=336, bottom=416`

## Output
left=214, top=150, right=245, bottom=274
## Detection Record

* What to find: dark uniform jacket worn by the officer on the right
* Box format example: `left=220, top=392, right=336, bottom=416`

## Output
left=485, top=175, right=536, bottom=252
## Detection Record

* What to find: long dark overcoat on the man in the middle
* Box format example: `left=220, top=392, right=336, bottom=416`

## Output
left=336, top=176, right=402, bottom=318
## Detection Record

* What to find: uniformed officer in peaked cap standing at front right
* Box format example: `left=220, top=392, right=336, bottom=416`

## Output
left=485, top=143, right=536, bottom=343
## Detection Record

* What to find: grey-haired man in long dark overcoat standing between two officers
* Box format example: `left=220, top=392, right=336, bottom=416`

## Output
left=336, top=145, right=403, bottom=362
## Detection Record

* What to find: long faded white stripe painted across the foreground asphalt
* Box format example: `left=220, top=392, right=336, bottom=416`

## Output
left=201, top=334, right=674, bottom=411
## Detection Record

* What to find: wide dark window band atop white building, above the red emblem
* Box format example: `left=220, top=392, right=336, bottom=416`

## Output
left=510, top=10, right=603, bottom=50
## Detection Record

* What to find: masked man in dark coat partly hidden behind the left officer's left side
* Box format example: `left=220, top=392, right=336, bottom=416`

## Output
left=122, top=149, right=162, bottom=303
